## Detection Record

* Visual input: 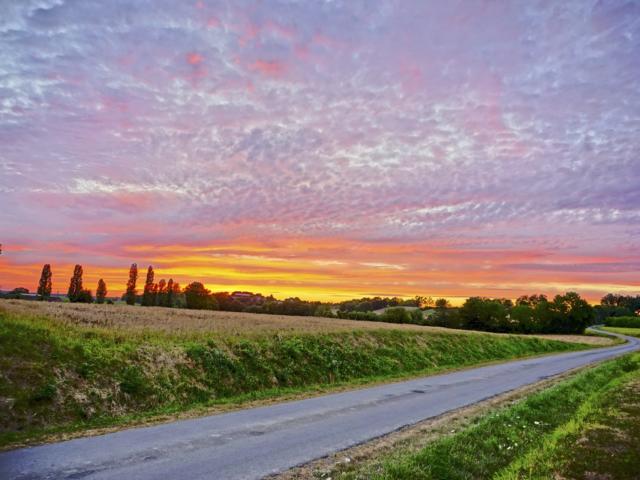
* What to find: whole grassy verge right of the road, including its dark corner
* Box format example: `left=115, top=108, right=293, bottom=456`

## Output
left=334, top=353, right=640, bottom=480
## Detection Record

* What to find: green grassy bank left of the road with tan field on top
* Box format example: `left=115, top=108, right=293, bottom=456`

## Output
left=0, top=301, right=586, bottom=446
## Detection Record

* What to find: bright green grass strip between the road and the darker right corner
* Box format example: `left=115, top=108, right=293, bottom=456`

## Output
left=337, top=354, right=640, bottom=480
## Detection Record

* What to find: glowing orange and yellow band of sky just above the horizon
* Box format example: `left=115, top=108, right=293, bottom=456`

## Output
left=0, top=238, right=637, bottom=305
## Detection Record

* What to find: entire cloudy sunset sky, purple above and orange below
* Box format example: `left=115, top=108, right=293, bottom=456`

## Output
left=0, top=0, right=640, bottom=302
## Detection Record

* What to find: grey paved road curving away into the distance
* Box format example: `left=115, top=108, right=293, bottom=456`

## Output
left=0, top=330, right=640, bottom=480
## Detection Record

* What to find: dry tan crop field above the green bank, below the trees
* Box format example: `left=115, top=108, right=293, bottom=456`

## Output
left=0, top=300, right=611, bottom=345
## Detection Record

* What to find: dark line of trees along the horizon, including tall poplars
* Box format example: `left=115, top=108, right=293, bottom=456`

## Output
left=5, top=263, right=640, bottom=333
